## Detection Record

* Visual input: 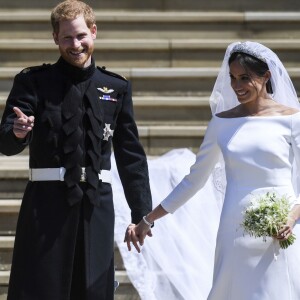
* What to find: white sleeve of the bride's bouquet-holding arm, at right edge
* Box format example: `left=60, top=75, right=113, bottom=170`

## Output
left=291, top=114, right=300, bottom=204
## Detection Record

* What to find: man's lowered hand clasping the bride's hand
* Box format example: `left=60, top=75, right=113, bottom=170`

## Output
left=124, top=220, right=152, bottom=253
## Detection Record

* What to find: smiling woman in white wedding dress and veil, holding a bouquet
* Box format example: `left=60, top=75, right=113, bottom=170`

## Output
left=125, top=42, right=300, bottom=300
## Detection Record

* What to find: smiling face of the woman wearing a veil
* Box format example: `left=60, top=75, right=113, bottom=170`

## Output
left=229, top=60, right=269, bottom=104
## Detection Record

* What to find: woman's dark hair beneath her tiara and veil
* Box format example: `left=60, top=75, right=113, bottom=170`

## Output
left=228, top=52, right=273, bottom=94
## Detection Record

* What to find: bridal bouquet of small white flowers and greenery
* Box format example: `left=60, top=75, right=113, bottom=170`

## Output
left=242, top=193, right=296, bottom=249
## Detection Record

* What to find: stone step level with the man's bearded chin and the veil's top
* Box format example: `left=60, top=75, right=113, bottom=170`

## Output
left=0, top=38, right=300, bottom=68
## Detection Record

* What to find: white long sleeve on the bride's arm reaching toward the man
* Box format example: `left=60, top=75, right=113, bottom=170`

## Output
left=161, top=118, right=221, bottom=213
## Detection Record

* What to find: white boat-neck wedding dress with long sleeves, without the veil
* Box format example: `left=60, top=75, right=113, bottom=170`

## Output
left=161, top=112, right=300, bottom=300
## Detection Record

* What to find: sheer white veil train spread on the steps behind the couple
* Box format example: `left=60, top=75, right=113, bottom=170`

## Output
left=112, top=149, right=223, bottom=300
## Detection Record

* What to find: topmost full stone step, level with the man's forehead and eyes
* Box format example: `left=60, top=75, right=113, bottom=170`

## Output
left=0, top=10, right=300, bottom=39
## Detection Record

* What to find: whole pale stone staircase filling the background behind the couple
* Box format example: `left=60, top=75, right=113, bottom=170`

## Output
left=0, top=0, right=300, bottom=300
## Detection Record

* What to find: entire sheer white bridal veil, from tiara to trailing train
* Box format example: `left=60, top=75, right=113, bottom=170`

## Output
left=112, top=42, right=299, bottom=300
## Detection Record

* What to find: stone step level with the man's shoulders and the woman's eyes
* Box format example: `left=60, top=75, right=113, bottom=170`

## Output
left=0, top=67, right=300, bottom=96
